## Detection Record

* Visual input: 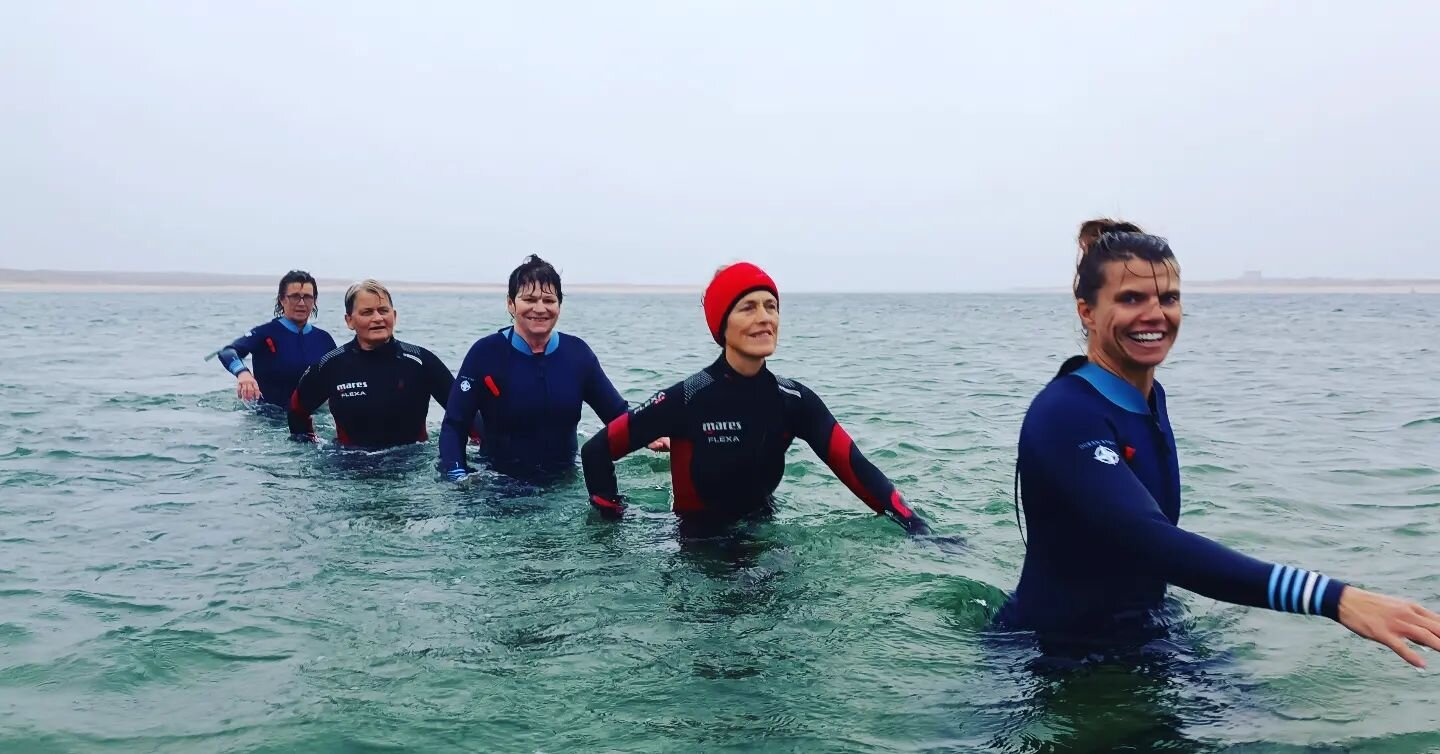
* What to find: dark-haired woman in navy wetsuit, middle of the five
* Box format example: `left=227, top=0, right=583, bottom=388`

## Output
left=439, top=255, right=662, bottom=481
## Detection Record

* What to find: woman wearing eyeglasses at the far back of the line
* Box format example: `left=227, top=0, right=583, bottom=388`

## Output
left=216, top=269, right=336, bottom=407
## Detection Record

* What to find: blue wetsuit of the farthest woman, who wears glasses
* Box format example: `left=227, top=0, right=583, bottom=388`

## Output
left=216, top=317, right=336, bottom=406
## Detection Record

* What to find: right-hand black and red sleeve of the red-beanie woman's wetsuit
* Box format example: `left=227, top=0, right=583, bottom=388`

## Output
left=782, top=383, right=924, bottom=530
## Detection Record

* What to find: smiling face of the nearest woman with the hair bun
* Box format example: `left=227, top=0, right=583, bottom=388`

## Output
left=1076, top=259, right=1182, bottom=377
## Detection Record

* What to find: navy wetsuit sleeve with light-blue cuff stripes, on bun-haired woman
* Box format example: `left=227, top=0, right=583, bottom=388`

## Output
left=1021, top=407, right=1345, bottom=619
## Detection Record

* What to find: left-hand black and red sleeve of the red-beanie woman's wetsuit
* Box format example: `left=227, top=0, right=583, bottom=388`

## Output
left=580, top=383, right=685, bottom=514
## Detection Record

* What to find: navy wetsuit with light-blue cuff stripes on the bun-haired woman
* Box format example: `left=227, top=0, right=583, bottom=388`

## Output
left=998, top=357, right=1345, bottom=635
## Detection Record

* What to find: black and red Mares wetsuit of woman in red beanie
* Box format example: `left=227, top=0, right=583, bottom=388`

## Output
left=580, top=355, right=924, bottom=532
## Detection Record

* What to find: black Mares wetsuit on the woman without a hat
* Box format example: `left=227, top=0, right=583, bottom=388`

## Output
left=289, top=340, right=454, bottom=449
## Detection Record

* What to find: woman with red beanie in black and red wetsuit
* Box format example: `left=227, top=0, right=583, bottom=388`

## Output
left=580, top=262, right=929, bottom=534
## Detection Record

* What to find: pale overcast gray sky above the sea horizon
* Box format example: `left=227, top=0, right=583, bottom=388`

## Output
left=0, top=0, right=1440, bottom=291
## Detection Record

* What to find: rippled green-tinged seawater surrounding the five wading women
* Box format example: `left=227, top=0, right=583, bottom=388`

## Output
left=0, top=291, right=1440, bottom=754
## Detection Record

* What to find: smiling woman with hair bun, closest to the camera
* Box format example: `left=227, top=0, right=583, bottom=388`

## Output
left=996, top=219, right=1440, bottom=668
